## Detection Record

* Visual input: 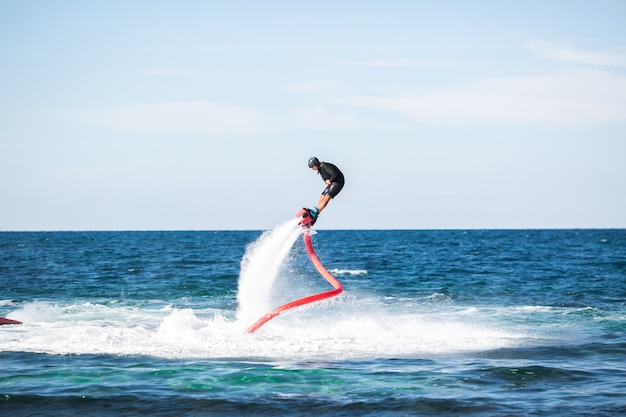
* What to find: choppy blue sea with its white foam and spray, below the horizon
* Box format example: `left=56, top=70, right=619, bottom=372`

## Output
left=0, top=221, right=626, bottom=417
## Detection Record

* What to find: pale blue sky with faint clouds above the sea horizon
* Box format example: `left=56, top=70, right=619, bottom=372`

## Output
left=0, top=0, right=626, bottom=230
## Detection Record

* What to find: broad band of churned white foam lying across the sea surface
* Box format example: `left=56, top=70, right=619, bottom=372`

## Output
left=0, top=297, right=576, bottom=360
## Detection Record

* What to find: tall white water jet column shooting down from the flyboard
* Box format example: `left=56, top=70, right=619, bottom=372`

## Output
left=237, top=218, right=303, bottom=321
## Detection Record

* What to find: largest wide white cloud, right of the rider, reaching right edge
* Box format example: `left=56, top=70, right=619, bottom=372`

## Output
left=316, top=71, right=626, bottom=126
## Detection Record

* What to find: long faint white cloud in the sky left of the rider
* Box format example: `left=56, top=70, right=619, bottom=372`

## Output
left=63, top=100, right=272, bottom=135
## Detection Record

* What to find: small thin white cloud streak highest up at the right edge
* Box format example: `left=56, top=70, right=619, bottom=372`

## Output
left=526, top=42, right=626, bottom=68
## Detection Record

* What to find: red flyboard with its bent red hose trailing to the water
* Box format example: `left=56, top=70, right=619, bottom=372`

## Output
left=246, top=208, right=343, bottom=334
